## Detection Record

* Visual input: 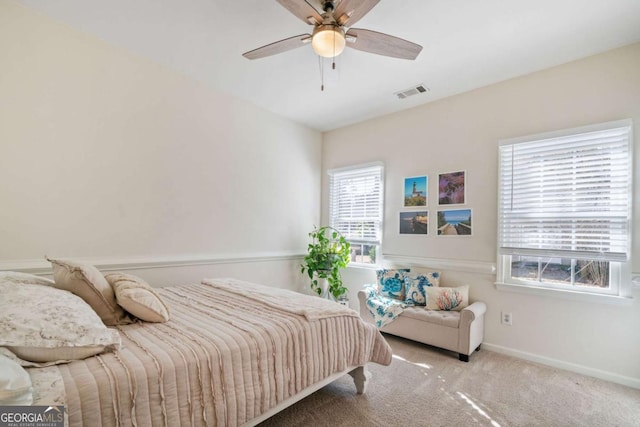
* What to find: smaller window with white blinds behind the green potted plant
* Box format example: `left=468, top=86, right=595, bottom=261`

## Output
left=329, top=163, right=384, bottom=264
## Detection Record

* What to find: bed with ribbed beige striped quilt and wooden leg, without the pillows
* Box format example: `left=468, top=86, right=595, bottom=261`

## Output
left=16, top=279, right=391, bottom=426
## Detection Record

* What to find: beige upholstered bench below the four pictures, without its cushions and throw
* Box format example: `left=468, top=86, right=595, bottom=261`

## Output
left=358, top=290, right=487, bottom=362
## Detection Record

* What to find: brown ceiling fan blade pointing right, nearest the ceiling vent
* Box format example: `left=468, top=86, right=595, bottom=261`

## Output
left=347, top=28, right=422, bottom=59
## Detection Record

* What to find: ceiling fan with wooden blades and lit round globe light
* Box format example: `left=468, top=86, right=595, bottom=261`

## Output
left=242, top=0, right=422, bottom=60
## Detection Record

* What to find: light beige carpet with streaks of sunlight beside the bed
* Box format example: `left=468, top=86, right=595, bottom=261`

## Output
left=260, top=335, right=640, bottom=427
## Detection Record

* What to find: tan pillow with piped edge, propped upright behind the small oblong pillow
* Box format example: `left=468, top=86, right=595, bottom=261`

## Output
left=47, top=258, right=132, bottom=326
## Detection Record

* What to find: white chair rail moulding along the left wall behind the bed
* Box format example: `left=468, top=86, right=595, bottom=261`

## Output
left=0, top=252, right=304, bottom=274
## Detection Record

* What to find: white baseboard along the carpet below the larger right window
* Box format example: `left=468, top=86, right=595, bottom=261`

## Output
left=482, top=342, right=640, bottom=389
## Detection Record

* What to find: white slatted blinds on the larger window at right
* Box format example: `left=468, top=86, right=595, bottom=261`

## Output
left=498, top=121, right=631, bottom=261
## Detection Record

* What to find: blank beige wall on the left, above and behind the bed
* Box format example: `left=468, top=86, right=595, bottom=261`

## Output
left=0, top=1, right=321, bottom=290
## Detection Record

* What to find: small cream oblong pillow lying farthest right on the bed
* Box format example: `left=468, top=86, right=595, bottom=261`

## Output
left=104, top=272, right=169, bottom=323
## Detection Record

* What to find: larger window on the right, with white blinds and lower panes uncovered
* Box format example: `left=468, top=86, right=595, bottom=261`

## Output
left=498, top=120, right=632, bottom=296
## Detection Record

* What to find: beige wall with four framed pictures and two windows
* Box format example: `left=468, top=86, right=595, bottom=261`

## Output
left=323, top=44, right=640, bottom=387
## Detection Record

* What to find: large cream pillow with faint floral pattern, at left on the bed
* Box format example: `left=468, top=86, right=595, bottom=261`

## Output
left=0, top=282, right=120, bottom=362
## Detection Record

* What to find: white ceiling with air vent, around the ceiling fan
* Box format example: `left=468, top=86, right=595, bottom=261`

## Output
left=18, top=0, right=640, bottom=131
